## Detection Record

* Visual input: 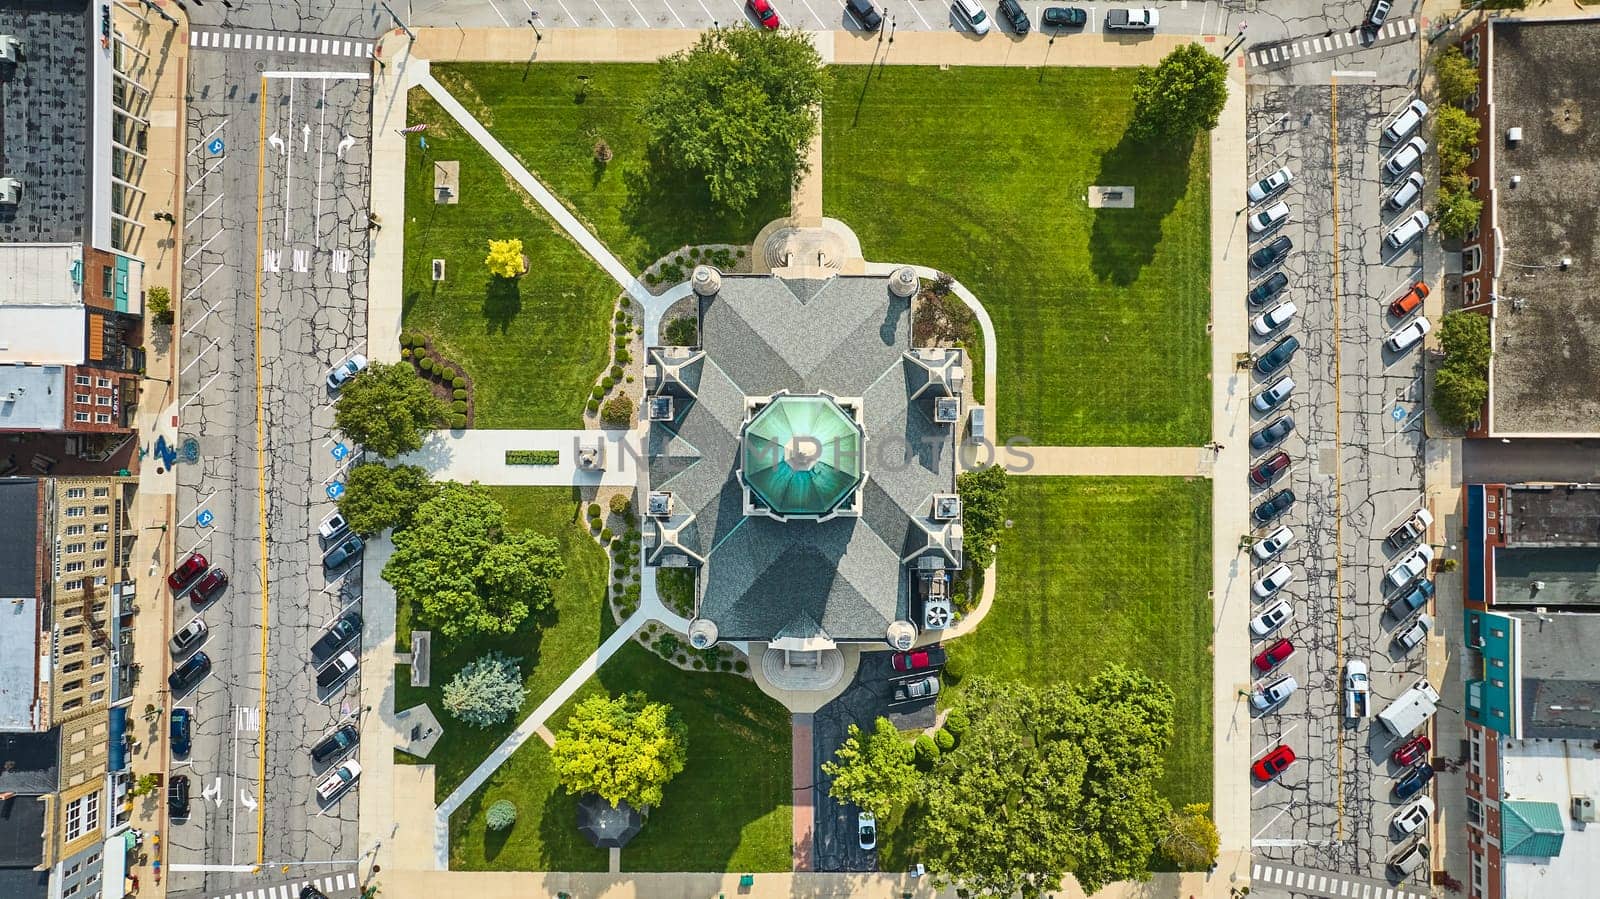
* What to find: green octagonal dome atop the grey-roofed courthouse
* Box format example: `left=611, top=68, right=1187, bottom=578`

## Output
left=739, top=395, right=861, bottom=515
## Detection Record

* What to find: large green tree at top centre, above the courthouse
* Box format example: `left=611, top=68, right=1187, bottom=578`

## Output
left=643, top=29, right=829, bottom=213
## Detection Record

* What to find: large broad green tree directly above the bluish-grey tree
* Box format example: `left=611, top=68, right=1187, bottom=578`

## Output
left=384, top=483, right=566, bottom=637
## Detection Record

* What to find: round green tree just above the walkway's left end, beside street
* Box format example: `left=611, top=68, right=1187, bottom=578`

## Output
left=333, top=362, right=445, bottom=457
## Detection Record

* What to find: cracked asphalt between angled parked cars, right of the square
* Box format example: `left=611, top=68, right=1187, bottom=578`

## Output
left=1240, top=78, right=1424, bottom=881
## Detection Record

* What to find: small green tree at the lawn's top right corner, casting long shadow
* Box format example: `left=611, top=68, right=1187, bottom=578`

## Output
left=1128, top=43, right=1227, bottom=142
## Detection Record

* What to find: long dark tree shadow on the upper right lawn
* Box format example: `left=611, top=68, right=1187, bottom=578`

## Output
left=1090, top=133, right=1203, bottom=286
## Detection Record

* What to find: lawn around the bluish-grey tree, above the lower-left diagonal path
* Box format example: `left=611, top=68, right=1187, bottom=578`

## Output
left=395, top=486, right=614, bottom=798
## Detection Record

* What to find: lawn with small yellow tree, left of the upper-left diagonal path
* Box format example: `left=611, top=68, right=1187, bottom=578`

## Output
left=403, top=88, right=619, bottom=429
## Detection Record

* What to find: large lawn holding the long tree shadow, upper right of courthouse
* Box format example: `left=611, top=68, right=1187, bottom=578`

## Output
left=822, top=66, right=1211, bottom=446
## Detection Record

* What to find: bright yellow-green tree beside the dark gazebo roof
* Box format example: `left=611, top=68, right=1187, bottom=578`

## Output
left=550, top=693, right=688, bottom=809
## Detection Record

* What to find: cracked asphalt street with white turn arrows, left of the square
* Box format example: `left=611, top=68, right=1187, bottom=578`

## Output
left=166, top=31, right=371, bottom=894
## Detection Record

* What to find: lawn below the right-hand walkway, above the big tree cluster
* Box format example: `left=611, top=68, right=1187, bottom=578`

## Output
left=946, top=477, right=1213, bottom=806
